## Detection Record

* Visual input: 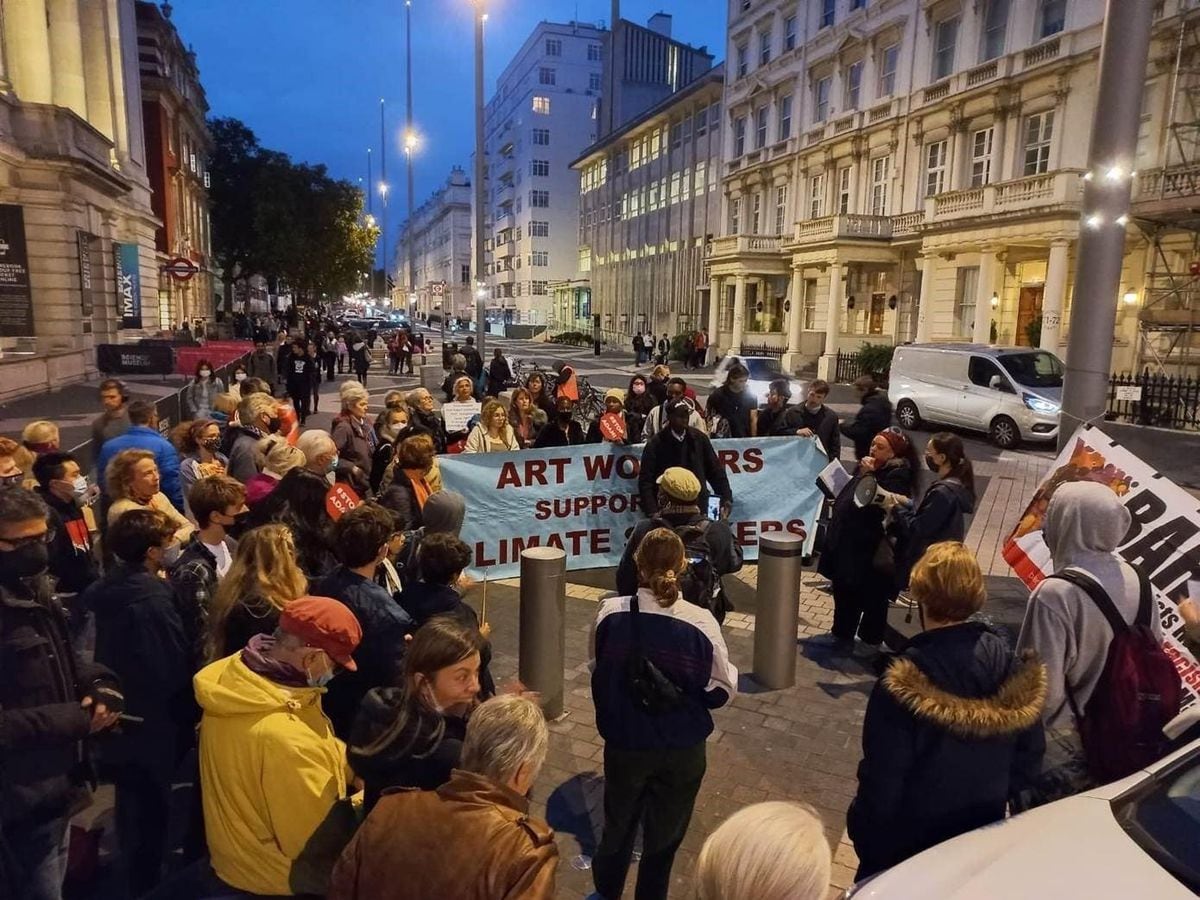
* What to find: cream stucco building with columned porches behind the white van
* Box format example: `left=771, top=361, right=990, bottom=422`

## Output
left=708, top=0, right=1196, bottom=374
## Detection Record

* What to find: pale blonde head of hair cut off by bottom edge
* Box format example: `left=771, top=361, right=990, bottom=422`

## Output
left=696, top=800, right=832, bottom=900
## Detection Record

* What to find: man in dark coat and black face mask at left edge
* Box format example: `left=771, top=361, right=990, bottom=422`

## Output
left=0, top=487, right=124, bottom=900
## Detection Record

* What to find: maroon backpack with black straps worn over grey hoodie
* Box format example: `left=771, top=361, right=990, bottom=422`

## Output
left=1050, top=569, right=1182, bottom=784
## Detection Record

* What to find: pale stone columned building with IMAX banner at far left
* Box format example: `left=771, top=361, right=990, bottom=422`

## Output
left=0, top=0, right=161, bottom=400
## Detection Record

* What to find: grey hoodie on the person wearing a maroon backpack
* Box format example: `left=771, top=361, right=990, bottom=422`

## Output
left=1016, top=481, right=1163, bottom=730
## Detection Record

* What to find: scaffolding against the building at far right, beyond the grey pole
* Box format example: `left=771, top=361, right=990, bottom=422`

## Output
left=1134, top=0, right=1200, bottom=376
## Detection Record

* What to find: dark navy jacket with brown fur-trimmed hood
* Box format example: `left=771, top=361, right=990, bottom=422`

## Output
left=846, top=622, right=1046, bottom=878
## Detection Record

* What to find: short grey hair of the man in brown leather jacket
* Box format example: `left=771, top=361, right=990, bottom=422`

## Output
left=462, top=694, right=550, bottom=784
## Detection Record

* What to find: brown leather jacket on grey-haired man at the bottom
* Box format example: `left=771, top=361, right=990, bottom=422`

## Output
left=329, top=769, right=558, bottom=900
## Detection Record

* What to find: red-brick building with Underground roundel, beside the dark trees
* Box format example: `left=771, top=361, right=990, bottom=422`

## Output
left=137, top=0, right=215, bottom=324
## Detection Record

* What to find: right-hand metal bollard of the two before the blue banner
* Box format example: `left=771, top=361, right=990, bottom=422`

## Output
left=754, top=533, right=804, bottom=690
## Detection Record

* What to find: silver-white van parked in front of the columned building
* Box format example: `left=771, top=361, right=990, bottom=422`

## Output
left=888, top=343, right=1062, bottom=449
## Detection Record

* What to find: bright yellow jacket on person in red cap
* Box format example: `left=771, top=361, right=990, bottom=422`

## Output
left=194, top=653, right=346, bottom=894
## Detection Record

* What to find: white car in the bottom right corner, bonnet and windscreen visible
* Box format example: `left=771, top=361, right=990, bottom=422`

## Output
left=844, top=740, right=1200, bottom=900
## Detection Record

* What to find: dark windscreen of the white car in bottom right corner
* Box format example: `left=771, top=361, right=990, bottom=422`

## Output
left=1112, top=752, right=1200, bottom=892
